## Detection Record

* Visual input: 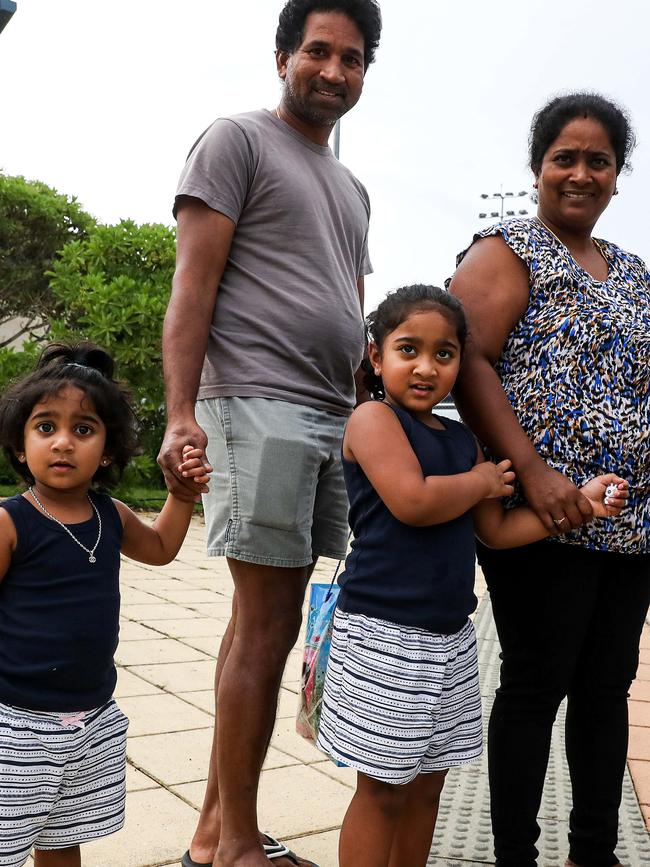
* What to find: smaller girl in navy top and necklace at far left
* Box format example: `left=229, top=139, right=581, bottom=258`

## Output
left=0, top=343, right=210, bottom=867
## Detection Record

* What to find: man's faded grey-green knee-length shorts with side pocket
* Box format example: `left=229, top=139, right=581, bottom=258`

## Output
left=196, top=397, right=348, bottom=568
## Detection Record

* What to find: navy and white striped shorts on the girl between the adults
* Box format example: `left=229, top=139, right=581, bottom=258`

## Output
left=317, top=609, right=483, bottom=785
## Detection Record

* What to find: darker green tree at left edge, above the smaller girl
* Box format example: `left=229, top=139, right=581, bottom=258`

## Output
left=0, top=172, right=95, bottom=346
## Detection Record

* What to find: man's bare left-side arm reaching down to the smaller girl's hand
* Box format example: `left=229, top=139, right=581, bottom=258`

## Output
left=158, top=196, right=235, bottom=499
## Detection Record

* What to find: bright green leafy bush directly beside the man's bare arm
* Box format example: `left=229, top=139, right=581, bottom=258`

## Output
left=50, top=220, right=176, bottom=480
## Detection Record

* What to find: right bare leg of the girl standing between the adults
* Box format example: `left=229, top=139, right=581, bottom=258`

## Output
left=388, top=770, right=447, bottom=867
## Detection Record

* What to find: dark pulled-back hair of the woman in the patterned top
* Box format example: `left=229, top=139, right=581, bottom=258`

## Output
left=528, top=92, right=636, bottom=175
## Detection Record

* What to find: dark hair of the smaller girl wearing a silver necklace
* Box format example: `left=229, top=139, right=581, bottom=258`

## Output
left=0, top=341, right=138, bottom=488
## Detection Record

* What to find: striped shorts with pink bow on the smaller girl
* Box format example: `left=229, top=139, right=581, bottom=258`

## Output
left=0, top=700, right=129, bottom=867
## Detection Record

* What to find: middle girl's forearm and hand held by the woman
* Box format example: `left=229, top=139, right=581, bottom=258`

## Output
left=472, top=473, right=629, bottom=548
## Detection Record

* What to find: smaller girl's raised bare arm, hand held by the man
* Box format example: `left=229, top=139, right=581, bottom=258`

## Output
left=115, top=446, right=211, bottom=566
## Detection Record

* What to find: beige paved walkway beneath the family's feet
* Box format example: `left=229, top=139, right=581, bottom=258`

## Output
left=58, top=520, right=650, bottom=867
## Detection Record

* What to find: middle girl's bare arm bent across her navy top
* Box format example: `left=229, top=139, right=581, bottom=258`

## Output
left=343, top=401, right=514, bottom=527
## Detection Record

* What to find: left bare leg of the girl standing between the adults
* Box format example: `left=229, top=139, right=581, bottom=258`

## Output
left=339, top=773, right=408, bottom=867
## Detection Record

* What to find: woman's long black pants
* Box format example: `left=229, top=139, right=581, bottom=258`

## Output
left=479, top=541, right=650, bottom=867
